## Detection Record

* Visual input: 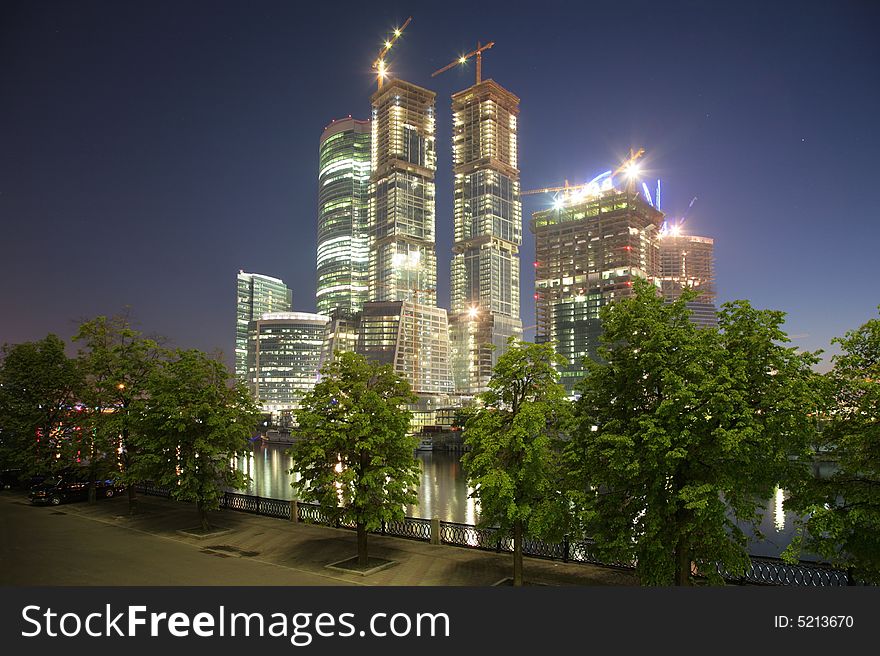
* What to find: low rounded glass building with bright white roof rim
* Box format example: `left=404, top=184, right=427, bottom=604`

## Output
left=247, top=312, right=330, bottom=417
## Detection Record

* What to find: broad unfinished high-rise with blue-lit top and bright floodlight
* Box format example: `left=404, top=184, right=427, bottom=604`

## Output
left=530, top=185, right=663, bottom=392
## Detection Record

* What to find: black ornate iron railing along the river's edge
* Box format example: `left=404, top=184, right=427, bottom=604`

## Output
left=136, top=483, right=861, bottom=587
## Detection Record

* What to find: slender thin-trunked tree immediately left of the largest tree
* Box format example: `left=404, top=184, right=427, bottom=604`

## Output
left=462, top=338, right=567, bottom=586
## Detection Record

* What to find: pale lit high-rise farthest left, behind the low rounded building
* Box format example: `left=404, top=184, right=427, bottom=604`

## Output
left=235, top=271, right=293, bottom=382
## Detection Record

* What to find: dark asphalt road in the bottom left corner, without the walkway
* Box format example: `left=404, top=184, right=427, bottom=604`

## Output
left=0, top=492, right=352, bottom=586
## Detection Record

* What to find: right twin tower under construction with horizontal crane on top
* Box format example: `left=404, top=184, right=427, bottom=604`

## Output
left=450, top=80, right=522, bottom=394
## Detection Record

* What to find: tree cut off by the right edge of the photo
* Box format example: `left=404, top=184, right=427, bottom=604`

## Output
left=786, top=304, right=880, bottom=583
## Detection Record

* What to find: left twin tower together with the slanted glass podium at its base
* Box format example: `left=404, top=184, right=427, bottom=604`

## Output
left=358, top=79, right=452, bottom=407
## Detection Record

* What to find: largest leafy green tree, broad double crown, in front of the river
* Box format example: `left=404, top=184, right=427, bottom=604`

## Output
left=567, top=281, right=816, bottom=585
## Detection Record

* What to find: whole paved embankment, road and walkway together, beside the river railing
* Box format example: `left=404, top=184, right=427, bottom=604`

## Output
left=0, top=492, right=637, bottom=586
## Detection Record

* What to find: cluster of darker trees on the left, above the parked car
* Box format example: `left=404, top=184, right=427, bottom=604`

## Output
left=0, top=316, right=259, bottom=528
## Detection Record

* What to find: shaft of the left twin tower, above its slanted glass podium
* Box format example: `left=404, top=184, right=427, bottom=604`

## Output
left=369, top=79, right=437, bottom=306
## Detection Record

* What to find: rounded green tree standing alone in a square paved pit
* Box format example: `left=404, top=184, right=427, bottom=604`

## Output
left=290, top=353, right=419, bottom=567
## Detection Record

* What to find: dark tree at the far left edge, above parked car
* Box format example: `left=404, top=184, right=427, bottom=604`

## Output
left=0, top=335, right=82, bottom=474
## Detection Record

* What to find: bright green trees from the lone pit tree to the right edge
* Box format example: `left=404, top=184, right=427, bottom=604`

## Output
left=291, top=282, right=880, bottom=585
